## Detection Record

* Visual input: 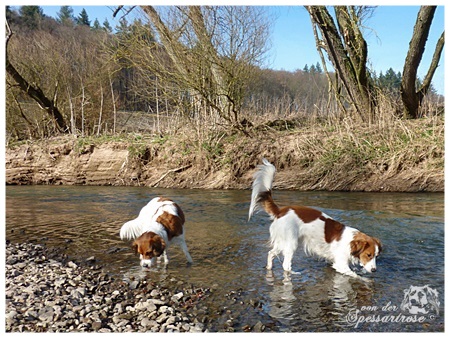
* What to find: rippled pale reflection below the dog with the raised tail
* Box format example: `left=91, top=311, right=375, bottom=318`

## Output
left=266, top=268, right=374, bottom=330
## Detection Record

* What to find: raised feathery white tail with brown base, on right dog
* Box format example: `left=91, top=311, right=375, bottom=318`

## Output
left=248, top=158, right=279, bottom=220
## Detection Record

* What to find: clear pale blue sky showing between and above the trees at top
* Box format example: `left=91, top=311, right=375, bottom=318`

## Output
left=14, top=2, right=445, bottom=94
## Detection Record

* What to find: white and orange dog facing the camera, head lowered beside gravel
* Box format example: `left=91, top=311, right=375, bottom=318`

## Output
left=120, top=197, right=192, bottom=267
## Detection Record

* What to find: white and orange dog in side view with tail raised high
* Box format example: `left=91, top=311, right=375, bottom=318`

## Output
left=249, top=159, right=381, bottom=276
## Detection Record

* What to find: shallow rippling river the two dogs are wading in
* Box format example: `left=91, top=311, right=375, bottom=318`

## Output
left=6, top=186, right=445, bottom=332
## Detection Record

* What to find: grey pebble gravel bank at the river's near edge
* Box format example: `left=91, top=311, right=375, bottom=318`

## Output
left=5, top=242, right=210, bottom=332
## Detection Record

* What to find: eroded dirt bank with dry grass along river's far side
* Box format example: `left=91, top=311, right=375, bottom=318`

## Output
left=5, top=120, right=444, bottom=192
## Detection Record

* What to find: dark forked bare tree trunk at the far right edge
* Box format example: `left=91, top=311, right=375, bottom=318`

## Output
left=400, top=6, right=445, bottom=118
